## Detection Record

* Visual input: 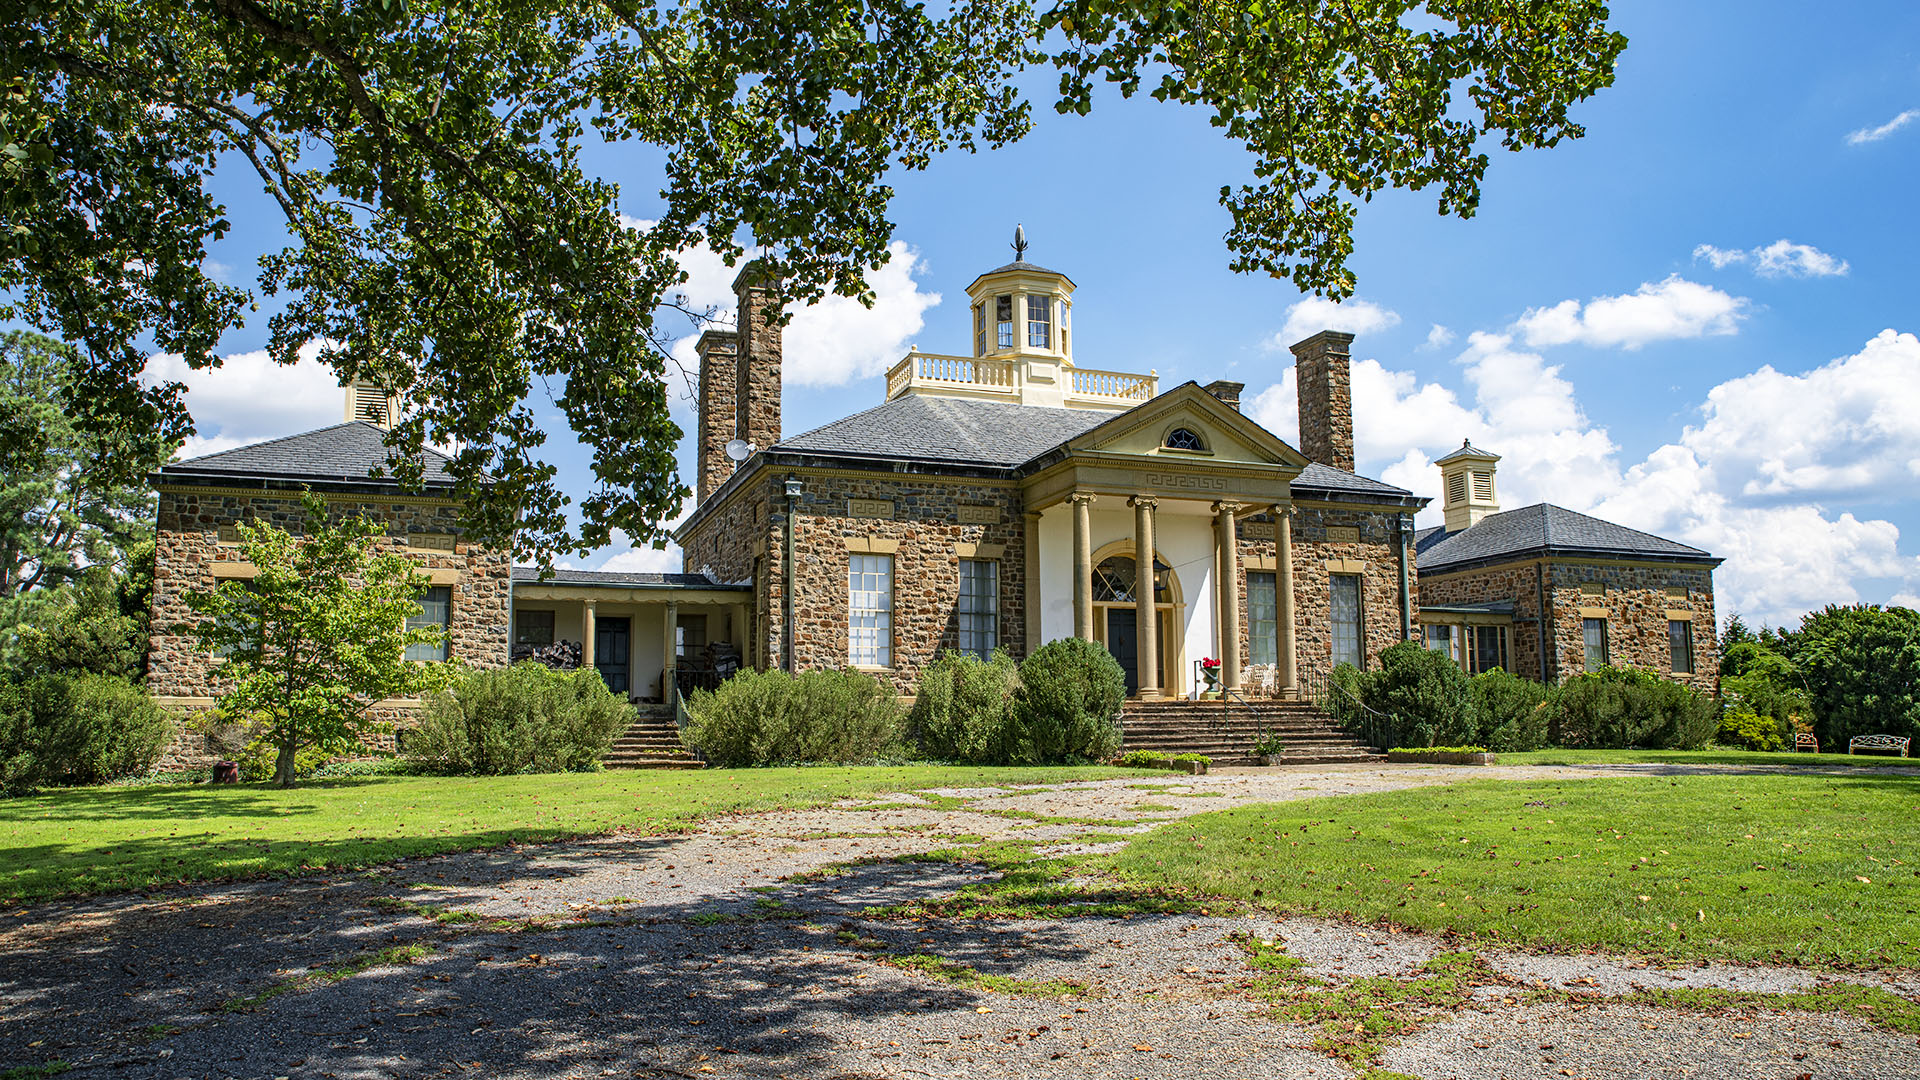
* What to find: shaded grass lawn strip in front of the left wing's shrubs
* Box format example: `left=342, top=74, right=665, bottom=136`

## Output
left=0, top=765, right=1133, bottom=903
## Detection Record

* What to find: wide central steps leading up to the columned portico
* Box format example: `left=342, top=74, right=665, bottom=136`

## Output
left=1119, top=698, right=1386, bottom=765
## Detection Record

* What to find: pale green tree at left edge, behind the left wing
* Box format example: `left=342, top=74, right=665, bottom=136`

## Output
left=0, top=331, right=177, bottom=601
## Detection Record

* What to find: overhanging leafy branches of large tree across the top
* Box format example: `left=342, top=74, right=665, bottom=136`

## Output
left=0, top=0, right=1626, bottom=555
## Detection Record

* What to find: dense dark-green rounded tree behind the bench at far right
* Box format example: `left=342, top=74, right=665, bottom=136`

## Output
left=1789, top=603, right=1920, bottom=746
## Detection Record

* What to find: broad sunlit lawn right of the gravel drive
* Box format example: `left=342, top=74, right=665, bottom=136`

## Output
left=1112, top=774, right=1920, bottom=969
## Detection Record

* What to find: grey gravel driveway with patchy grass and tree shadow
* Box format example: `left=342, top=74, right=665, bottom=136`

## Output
left=0, top=767, right=1920, bottom=1080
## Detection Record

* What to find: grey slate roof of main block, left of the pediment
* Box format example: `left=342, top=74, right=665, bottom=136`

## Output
left=774, top=394, right=1116, bottom=469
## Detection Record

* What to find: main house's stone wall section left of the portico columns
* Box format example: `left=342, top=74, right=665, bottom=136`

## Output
left=766, top=473, right=1027, bottom=694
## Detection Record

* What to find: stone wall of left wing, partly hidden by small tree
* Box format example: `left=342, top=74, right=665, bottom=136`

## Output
left=148, top=488, right=513, bottom=749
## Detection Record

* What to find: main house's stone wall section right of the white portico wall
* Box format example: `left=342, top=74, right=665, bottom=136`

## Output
left=1238, top=505, right=1417, bottom=682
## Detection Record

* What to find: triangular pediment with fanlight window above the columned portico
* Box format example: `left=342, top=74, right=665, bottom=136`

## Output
left=1068, top=382, right=1308, bottom=469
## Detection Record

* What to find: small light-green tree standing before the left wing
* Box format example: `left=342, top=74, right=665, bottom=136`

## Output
left=179, top=492, right=445, bottom=788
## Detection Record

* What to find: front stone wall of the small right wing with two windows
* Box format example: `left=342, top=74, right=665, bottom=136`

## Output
left=1546, top=561, right=1720, bottom=692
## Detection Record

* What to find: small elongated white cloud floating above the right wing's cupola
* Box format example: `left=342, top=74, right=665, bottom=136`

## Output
left=1513, top=275, right=1747, bottom=350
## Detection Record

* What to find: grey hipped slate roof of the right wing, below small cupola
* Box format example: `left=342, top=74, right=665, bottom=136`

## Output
left=1413, top=503, right=1720, bottom=575
